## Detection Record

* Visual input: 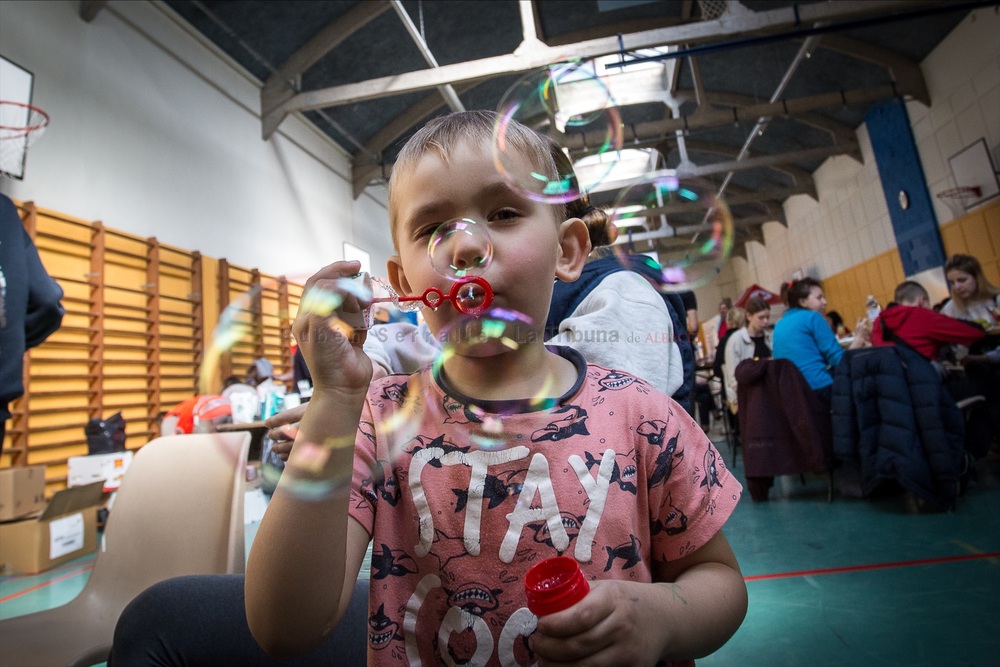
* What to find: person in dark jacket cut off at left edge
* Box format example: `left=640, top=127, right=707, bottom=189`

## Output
left=0, top=195, right=65, bottom=449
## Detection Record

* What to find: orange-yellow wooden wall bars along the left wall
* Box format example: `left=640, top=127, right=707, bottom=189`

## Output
left=0, top=202, right=302, bottom=491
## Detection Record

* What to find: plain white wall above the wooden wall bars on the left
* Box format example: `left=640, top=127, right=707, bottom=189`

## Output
left=0, top=0, right=391, bottom=279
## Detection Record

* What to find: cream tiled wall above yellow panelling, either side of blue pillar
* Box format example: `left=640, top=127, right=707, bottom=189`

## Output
left=732, top=8, right=1000, bottom=300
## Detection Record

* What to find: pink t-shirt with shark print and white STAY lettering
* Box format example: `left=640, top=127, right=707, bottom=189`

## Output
left=351, top=348, right=742, bottom=666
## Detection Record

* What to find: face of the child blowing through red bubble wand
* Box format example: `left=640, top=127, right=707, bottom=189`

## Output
left=388, top=140, right=587, bottom=342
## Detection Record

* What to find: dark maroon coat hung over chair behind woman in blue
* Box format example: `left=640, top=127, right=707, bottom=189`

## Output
left=736, top=359, right=833, bottom=502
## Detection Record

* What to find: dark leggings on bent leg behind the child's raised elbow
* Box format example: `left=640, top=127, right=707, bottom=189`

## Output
left=108, top=574, right=368, bottom=667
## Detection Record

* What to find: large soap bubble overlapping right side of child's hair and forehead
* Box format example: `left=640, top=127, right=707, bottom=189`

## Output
left=493, top=62, right=623, bottom=204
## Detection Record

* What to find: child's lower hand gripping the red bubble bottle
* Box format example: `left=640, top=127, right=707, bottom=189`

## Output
left=530, top=580, right=669, bottom=667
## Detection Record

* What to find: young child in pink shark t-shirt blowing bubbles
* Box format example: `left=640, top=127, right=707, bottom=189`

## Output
left=246, top=112, right=747, bottom=666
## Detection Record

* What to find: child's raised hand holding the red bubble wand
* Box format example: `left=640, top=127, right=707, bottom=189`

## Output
left=292, top=262, right=372, bottom=394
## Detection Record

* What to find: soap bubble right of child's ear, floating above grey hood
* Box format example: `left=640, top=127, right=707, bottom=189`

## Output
left=611, top=170, right=734, bottom=291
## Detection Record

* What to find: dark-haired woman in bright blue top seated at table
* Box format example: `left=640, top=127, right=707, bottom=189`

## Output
left=773, top=278, right=871, bottom=407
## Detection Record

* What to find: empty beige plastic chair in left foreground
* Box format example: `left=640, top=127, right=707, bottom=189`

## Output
left=0, top=433, right=250, bottom=667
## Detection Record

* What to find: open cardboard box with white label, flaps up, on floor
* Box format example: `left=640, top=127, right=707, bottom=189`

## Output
left=0, top=482, right=104, bottom=575
